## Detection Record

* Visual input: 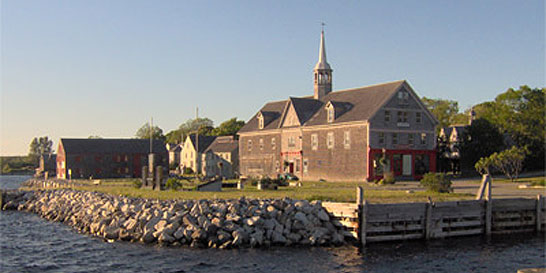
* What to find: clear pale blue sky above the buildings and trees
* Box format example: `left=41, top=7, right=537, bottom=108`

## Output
left=0, top=0, right=545, bottom=155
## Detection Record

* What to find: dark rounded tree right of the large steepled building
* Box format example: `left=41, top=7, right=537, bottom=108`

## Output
left=460, top=119, right=504, bottom=170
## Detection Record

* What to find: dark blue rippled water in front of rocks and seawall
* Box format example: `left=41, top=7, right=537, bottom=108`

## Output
left=0, top=176, right=546, bottom=273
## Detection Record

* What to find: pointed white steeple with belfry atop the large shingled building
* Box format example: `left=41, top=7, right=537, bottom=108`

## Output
left=313, top=23, right=332, bottom=100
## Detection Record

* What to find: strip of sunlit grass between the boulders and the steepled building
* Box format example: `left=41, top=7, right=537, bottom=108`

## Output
left=52, top=179, right=474, bottom=203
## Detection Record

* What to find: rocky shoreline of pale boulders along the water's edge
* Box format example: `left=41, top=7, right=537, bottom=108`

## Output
left=0, top=189, right=345, bottom=249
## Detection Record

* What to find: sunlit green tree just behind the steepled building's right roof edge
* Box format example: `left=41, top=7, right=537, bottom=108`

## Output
left=421, top=97, right=461, bottom=130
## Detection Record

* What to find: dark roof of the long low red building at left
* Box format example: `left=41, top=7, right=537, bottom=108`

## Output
left=60, top=138, right=167, bottom=154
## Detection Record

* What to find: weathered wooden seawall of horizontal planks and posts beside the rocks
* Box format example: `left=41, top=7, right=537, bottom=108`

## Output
left=322, top=175, right=546, bottom=245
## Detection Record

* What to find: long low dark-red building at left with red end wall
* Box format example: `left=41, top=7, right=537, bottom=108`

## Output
left=57, top=138, right=168, bottom=179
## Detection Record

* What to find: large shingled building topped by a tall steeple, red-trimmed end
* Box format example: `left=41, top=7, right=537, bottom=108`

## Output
left=238, top=29, right=438, bottom=181
